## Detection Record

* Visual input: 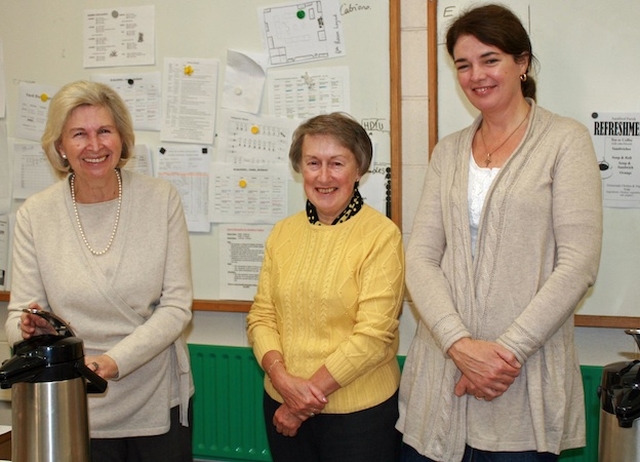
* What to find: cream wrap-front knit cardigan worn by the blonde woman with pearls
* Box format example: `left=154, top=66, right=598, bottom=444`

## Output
left=6, top=170, right=193, bottom=438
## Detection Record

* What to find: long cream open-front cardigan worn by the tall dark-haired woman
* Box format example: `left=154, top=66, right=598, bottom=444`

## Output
left=398, top=101, right=602, bottom=462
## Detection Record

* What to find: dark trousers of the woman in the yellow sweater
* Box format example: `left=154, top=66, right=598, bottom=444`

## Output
left=264, top=392, right=402, bottom=462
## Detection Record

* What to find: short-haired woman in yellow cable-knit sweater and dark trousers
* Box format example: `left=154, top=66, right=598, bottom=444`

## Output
left=247, top=113, right=404, bottom=462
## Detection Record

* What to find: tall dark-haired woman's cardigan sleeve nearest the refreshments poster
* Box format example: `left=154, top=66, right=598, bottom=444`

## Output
left=498, top=119, right=603, bottom=362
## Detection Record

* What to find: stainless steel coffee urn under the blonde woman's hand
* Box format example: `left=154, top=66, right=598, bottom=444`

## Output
left=0, top=310, right=107, bottom=462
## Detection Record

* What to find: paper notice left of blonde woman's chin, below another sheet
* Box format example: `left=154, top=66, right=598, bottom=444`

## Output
left=13, top=143, right=58, bottom=199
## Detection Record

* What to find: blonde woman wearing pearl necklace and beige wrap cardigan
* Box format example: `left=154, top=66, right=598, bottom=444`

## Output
left=6, top=81, right=193, bottom=462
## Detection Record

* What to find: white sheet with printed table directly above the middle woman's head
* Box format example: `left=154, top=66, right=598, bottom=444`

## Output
left=267, top=66, right=351, bottom=120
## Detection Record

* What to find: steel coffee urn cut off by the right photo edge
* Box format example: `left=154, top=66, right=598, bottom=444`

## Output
left=598, top=329, right=640, bottom=462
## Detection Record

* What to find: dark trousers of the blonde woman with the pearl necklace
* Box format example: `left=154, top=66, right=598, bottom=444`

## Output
left=91, top=401, right=193, bottom=462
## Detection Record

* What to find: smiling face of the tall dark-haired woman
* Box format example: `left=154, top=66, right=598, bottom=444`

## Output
left=453, top=35, right=528, bottom=113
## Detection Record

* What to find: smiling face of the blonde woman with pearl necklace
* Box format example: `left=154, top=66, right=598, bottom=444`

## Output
left=57, top=105, right=122, bottom=185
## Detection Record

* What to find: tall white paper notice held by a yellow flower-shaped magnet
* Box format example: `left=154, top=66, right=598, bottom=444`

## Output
left=160, top=58, right=219, bottom=145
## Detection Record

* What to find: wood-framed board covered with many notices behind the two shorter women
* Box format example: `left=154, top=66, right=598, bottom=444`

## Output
left=0, top=0, right=402, bottom=312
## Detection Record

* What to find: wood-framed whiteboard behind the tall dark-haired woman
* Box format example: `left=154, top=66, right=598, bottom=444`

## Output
left=428, top=0, right=640, bottom=328
